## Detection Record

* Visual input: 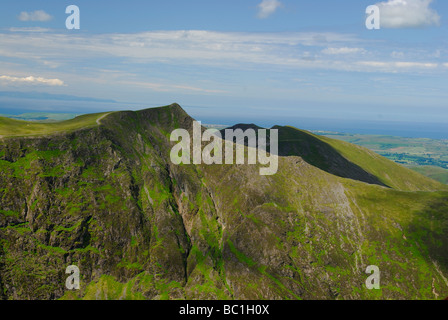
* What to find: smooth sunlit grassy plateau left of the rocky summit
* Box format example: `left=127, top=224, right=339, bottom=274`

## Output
left=0, top=112, right=111, bottom=137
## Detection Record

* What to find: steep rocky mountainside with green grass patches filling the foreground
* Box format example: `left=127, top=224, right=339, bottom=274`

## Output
left=0, top=104, right=448, bottom=299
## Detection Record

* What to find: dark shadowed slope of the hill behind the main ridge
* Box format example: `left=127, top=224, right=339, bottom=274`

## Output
left=221, top=124, right=389, bottom=187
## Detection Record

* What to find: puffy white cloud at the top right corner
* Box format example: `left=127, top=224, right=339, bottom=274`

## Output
left=376, top=0, right=440, bottom=28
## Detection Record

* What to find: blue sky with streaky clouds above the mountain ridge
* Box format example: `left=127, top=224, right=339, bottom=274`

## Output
left=0, top=0, right=448, bottom=130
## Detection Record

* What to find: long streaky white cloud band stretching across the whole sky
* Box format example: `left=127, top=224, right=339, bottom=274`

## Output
left=0, top=30, right=446, bottom=77
